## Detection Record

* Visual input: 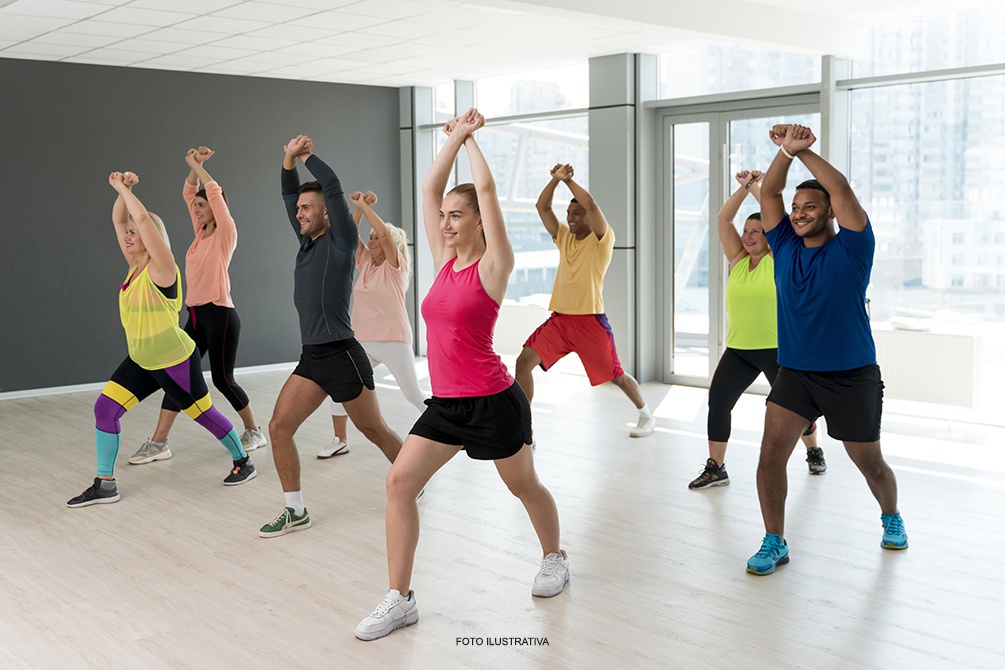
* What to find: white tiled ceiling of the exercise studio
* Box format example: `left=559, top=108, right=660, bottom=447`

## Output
left=0, top=0, right=1001, bottom=86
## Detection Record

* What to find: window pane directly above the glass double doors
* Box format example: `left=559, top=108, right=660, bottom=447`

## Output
left=659, top=39, right=820, bottom=98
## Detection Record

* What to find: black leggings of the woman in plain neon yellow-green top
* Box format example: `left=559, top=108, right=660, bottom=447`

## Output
left=709, top=349, right=778, bottom=442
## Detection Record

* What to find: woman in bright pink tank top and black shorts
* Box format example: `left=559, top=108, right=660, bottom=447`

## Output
left=356, top=109, right=569, bottom=640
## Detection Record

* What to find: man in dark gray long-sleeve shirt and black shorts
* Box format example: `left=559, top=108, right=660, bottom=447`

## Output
left=258, top=135, right=401, bottom=537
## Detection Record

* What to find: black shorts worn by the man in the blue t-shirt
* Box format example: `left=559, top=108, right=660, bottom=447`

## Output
left=768, top=366, right=883, bottom=442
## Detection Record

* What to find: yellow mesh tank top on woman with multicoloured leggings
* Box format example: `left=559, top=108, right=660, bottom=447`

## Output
left=119, top=265, right=195, bottom=370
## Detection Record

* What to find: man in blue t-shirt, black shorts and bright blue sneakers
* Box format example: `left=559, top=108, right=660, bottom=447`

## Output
left=747, top=125, right=908, bottom=575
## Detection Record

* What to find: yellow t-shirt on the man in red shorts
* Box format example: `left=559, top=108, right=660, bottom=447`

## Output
left=548, top=223, right=614, bottom=314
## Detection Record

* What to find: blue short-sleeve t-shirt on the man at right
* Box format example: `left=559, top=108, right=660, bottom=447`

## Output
left=765, top=214, right=876, bottom=372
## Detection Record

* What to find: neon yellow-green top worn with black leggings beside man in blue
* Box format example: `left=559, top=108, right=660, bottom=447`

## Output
left=726, top=255, right=778, bottom=350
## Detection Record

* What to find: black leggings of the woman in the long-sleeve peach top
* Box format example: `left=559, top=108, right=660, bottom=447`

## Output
left=161, top=302, right=248, bottom=412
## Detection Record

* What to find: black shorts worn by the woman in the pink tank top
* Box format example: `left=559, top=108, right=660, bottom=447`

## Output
left=409, top=382, right=534, bottom=461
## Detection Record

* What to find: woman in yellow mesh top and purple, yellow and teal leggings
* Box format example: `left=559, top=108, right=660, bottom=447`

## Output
left=66, top=172, right=256, bottom=507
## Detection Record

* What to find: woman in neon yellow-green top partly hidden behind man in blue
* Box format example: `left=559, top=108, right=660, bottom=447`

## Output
left=687, top=170, right=827, bottom=489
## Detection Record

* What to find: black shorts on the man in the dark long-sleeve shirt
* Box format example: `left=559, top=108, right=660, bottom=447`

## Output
left=293, top=338, right=374, bottom=403
